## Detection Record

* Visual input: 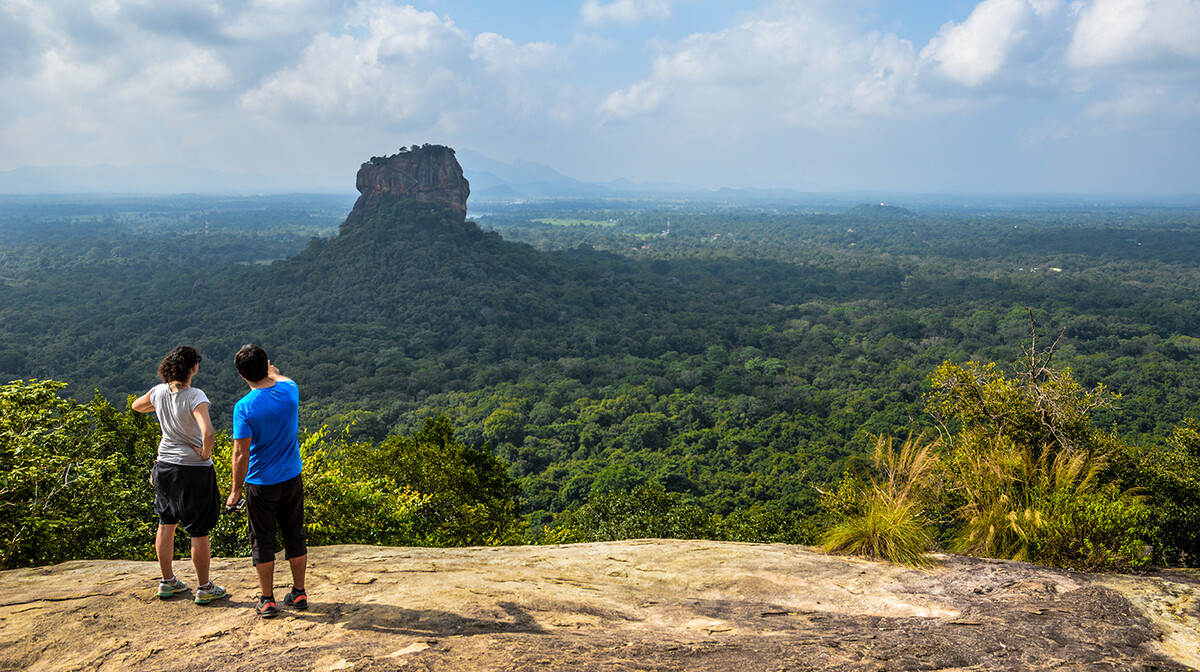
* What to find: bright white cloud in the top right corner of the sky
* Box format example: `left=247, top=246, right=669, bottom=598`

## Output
left=1068, top=0, right=1200, bottom=68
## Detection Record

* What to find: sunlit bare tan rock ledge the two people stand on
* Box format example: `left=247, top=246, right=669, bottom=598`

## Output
left=0, top=540, right=1200, bottom=672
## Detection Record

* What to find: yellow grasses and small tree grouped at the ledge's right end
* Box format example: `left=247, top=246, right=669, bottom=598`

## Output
left=822, top=316, right=1166, bottom=571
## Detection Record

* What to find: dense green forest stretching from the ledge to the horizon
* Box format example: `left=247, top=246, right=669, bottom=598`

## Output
left=0, top=197, right=1200, bottom=563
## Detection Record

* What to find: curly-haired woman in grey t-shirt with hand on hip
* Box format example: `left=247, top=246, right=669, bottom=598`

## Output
left=133, top=346, right=228, bottom=605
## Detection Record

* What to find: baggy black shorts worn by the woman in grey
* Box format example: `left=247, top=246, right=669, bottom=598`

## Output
left=151, top=462, right=221, bottom=538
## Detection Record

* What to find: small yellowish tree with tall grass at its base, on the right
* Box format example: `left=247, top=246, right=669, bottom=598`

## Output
left=926, top=311, right=1147, bottom=569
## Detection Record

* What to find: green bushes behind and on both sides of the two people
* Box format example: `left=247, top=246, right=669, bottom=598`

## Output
left=0, top=380, right=524, bottom=569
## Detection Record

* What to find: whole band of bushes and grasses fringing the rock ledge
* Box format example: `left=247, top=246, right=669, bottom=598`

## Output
left=0, top=358, right=1200, bottom=570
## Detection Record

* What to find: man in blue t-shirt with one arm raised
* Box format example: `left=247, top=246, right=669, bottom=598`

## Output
left=227, top=344, right=308, bottom=618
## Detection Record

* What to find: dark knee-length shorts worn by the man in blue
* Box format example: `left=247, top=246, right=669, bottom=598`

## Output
left=246, top=475, right=308, bottom=565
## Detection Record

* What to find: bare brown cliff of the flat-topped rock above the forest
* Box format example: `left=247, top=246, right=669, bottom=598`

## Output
left=346, top=144, right=470, bottom=223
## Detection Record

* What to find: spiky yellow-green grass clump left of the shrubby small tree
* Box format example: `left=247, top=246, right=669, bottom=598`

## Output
left=821, top=434, right=941, bottom=566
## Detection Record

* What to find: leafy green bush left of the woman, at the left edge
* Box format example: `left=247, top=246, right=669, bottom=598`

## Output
left=0, top=380, right=158, bottom=569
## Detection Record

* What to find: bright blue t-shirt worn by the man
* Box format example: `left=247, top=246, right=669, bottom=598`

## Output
left=233, top=380, right=301, bottom=485
